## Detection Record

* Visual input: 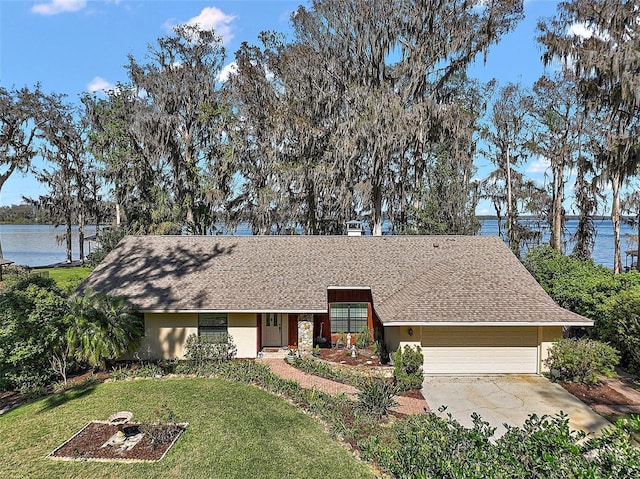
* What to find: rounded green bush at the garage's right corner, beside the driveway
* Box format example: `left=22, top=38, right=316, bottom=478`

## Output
left=545, top=339, right=620, bottom=384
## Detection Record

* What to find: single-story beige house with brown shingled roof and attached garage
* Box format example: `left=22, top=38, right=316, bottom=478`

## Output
left=82, top=236, right=592, bottom=374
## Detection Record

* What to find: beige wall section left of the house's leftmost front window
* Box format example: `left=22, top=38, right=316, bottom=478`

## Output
left=139, top=313, right=198, bottom=359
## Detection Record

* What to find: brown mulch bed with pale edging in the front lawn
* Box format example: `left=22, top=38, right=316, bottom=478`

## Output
left=49, top=421, right=187, bottom=462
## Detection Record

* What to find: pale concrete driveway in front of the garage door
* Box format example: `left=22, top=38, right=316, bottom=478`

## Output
left=422, top=374, right=611, bottom=437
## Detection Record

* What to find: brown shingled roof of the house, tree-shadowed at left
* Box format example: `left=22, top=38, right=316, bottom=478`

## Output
left=82, top=236, right=592, bottom=325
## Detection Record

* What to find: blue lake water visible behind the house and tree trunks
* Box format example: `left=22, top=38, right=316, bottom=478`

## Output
left=0, top=220, right=636, bottom=267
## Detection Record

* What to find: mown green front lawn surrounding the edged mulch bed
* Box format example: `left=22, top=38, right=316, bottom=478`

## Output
left=0, top=378, right=374, bottom=479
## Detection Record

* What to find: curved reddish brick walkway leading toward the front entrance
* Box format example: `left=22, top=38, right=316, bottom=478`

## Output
left=258, top=358, right=429, bottom=414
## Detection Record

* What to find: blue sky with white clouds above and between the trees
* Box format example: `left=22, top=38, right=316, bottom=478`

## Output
left=0, top=0, right=558, bottom=213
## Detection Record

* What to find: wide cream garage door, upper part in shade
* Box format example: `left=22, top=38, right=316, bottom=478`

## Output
left=422, top=326, right=538, bottom=374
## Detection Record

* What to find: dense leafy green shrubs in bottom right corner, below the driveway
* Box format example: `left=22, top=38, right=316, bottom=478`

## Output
left=359, top=414, right=640, bottom=479
